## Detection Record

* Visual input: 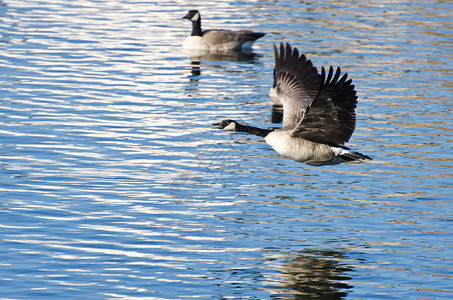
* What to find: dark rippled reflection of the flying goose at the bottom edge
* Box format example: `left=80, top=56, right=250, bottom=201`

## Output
left=277, top=250, right=352, bottom=300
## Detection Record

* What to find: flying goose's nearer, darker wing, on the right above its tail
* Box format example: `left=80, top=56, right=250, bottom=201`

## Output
left=293, top=67, right=357, bottom=145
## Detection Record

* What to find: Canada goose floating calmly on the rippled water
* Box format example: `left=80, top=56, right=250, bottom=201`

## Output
left=183, top=10, right=265, bottom=51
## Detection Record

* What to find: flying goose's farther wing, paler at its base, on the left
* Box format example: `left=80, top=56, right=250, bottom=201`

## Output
left=273, top=43, right=322, bottom=130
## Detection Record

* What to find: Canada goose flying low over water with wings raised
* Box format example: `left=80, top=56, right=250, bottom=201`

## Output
left=214, top=43, right=371, bottom=166
